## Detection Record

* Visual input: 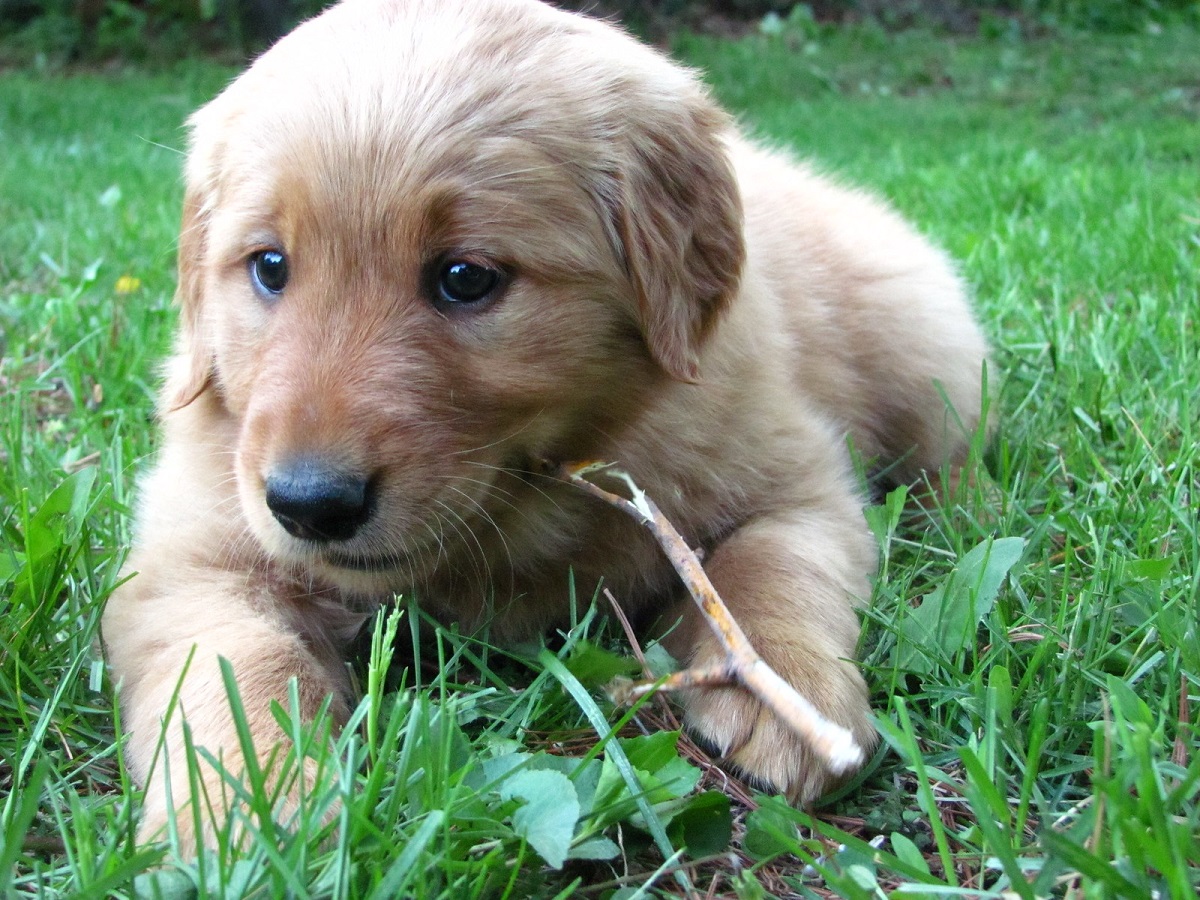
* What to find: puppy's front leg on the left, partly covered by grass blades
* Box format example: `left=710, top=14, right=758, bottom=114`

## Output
left=102, top=566, right=349, bottom=853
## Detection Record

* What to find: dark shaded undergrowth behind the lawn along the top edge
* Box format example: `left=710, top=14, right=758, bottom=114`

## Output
left=0, top=0, right=1200, bottom=67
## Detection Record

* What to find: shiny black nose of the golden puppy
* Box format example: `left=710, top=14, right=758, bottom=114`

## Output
left=266, top=456, right=372, bottom=542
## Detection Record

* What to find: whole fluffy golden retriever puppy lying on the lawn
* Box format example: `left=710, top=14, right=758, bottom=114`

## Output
left=103, top=0, right=986, bottom=854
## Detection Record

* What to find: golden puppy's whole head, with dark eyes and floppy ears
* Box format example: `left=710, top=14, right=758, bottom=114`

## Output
left=166, top=0, right=743, bottom=589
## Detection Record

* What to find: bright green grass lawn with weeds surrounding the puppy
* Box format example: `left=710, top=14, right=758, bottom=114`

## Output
left=0, top=21, right=1200, bottom=898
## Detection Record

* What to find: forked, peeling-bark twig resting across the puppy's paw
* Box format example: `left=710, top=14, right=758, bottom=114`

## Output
left=557, top=462, right=863, bottom=773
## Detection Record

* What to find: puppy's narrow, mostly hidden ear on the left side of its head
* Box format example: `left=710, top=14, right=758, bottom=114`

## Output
left=163, top=127, right=214, bottom=412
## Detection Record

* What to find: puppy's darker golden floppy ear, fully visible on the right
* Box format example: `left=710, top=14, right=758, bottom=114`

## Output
left=616, top=94, right=745, bottom=382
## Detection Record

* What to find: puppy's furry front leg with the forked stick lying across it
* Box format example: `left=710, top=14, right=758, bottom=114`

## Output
left=668, top=496, right=877, bottom=805
